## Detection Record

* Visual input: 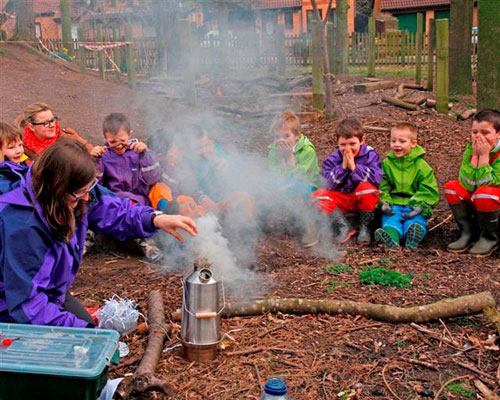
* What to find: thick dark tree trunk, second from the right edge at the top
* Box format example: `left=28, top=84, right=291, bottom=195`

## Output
left=450, top=0, right=472, bottom=94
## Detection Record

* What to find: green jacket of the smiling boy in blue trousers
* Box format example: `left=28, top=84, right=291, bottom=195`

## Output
left=379, top=145, right=439, bottom=218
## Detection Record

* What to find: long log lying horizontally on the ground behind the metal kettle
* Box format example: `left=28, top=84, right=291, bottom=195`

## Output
left=172, top=292, right=495, bottom=323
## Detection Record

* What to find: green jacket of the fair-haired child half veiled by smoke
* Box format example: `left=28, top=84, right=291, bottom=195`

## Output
left=267, top=135, right=320, bottom=188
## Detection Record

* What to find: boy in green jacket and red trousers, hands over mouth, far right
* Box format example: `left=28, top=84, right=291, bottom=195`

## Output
left=444, top=110, right=500, bottom=257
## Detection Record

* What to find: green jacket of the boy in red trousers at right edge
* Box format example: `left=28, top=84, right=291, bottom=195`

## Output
left=459, top=141, right=500, bottom=192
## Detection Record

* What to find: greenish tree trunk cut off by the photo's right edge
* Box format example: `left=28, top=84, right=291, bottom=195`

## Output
left=477, top=0, right=500, bottom=110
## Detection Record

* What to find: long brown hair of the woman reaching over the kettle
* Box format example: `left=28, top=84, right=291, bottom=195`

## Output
left=32, top=138, right=97, bottom=242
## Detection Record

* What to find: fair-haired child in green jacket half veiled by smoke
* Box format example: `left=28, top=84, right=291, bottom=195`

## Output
left=268, top=111, right=320, bottom=248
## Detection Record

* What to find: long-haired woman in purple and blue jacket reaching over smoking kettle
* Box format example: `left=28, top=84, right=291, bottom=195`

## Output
left=0, top=139, right=197, bottom=327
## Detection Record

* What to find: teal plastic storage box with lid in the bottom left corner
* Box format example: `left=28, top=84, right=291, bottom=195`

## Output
left=0, top=323, right=120, bottom=400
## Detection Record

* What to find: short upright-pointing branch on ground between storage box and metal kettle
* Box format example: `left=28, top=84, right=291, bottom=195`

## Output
left=116, top=290, right=175, bottom=400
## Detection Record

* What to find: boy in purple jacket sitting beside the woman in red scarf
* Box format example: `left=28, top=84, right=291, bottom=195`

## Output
left=90, top=113, right=178, bottom=262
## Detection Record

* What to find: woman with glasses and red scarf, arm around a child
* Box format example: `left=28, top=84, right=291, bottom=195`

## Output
left=16, top=103, right=94, bottom=159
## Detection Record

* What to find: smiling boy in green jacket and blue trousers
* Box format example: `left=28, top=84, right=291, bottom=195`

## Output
left=375, top=123, right=439, bottom=248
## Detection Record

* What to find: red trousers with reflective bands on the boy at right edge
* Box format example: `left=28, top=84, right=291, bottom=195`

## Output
left=444, top=181, right=500, bottom=212
